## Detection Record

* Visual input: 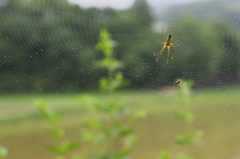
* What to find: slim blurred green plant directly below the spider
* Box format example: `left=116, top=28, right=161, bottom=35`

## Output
left=158, top=80, right=203, bottom=159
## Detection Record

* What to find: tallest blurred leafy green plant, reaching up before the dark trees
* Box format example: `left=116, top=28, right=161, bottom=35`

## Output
left=81, top=29, right=146, bottom=159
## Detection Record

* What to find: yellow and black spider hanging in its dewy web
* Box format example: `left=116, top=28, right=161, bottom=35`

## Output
left=153, top=26, right=183, bottom=64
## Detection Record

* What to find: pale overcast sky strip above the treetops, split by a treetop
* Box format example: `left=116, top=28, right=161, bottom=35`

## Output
left=68, top=0, right=197, bottom=9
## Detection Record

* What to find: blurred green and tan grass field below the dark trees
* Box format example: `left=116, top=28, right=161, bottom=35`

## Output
left=0, top=87, right=240, bottom=159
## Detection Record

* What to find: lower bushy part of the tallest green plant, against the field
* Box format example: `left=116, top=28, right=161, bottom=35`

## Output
left=79, top=95, right=146, bottom=159
